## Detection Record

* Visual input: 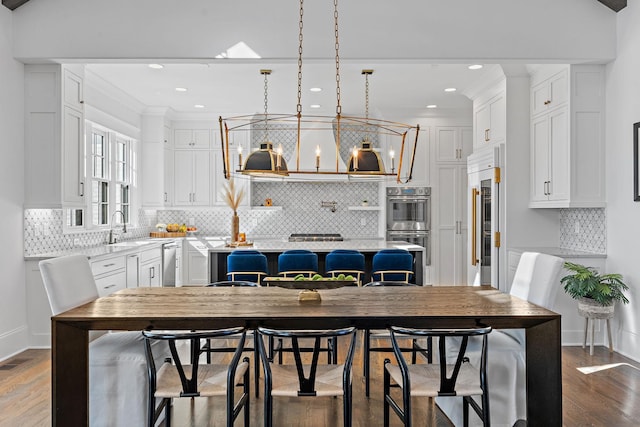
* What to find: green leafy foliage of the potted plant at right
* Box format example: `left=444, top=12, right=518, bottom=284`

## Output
left=560, top=262, right=629, bottom=305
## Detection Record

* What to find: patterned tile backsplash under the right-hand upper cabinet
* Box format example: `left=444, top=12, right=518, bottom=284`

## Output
left=560, top=208, right=607, bottom=254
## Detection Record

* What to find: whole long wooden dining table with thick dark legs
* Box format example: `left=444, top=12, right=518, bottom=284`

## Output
left=51, top=286, right=562, bottom=427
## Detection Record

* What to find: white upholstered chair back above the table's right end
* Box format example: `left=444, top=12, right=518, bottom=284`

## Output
left=509, top=252, right=564, bottom=309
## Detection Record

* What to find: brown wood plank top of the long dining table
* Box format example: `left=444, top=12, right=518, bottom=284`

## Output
left=54, top=286, right=560, bottom=330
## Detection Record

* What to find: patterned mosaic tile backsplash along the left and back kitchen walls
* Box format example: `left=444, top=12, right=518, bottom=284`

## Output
left=24, top=182, right=383, bottom=256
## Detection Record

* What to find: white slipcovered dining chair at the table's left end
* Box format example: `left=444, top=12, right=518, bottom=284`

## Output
left=39, top=255, right=171, bottom=427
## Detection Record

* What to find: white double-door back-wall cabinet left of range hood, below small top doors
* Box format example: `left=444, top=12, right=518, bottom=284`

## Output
left=174, top=150, right=213, bottom=206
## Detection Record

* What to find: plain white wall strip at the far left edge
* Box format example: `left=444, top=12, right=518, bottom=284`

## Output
left=0, top=7, right=27, bottom=360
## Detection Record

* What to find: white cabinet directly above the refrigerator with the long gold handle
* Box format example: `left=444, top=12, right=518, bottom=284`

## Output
left=473, top=92, right=507, bottom=148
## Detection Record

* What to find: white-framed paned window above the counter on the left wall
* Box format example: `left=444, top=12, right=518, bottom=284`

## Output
left=87, top=123, right=136, bottom=227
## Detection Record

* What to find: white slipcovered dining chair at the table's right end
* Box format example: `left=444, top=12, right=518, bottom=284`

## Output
left=436, top=252, right=564, bottom=427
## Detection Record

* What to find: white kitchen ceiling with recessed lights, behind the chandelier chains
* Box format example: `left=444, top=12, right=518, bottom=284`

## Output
left=86, top=60, right=499, bottom=120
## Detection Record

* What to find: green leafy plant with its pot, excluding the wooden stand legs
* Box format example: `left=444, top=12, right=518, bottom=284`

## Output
left=560, top=262, right=629, bottom=319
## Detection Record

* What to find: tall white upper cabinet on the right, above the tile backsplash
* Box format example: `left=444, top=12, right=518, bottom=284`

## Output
left=529, top=65, right=605, bottom=208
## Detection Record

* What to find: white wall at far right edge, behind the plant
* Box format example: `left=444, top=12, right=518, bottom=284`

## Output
left=606, top=1, right=640, bottom=360
